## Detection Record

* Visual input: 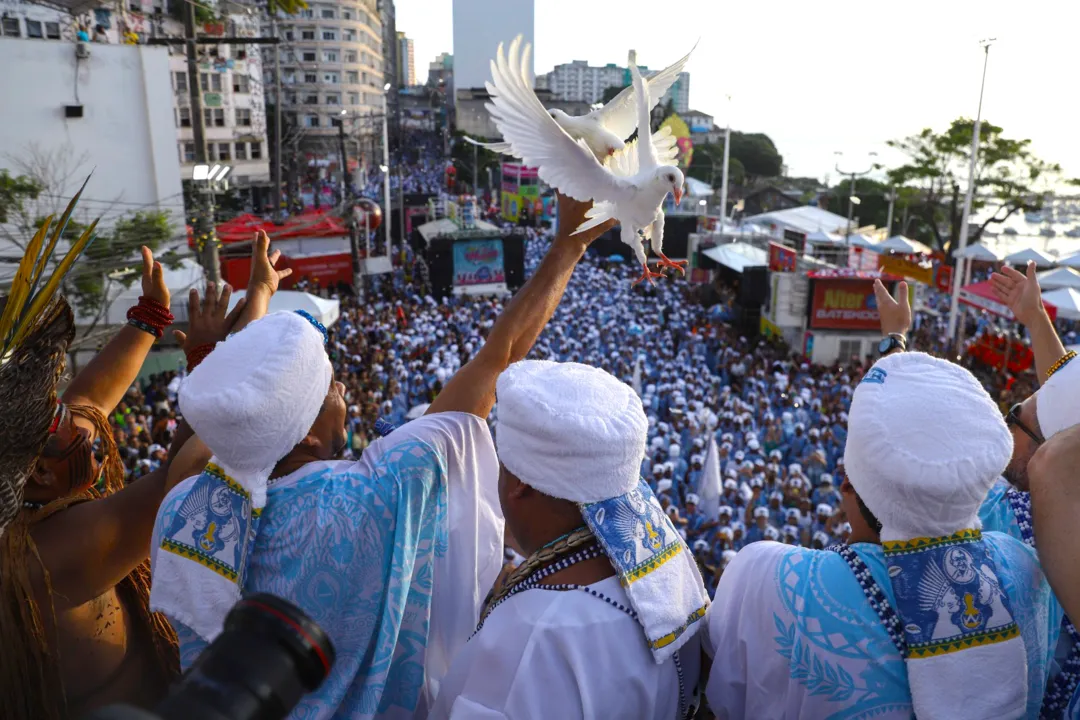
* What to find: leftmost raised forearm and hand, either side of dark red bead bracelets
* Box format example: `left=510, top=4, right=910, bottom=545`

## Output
left=63, top=247, right=170, bottom=418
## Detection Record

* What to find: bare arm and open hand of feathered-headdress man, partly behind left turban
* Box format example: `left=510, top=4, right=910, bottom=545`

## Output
left=32, top=287, right=243, bottom=608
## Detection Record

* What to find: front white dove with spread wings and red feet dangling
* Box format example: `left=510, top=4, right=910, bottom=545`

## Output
left=487, top=36, right=684, bottom=284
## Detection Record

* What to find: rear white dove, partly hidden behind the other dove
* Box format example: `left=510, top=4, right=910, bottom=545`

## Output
left=465, top=43, right=698, bottom=162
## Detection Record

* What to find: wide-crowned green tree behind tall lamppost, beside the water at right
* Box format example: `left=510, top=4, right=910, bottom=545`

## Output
left=888, top=118, right=1061, bottom=254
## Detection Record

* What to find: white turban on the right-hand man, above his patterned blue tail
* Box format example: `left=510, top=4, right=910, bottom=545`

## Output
left=845, top=353, right=1012, bottom=540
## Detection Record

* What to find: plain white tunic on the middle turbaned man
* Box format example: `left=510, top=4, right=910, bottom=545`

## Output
left=430, top=578, right=701, bottom=720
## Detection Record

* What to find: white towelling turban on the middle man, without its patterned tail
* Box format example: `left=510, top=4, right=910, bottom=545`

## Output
left=496, top=361, right=649, bottom=503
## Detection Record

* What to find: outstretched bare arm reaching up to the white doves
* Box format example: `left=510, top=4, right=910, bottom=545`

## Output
left=428, top=194, right=613, bottom=418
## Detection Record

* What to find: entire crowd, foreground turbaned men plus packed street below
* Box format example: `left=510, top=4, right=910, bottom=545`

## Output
left=6, top=143, right=1080, bottom=720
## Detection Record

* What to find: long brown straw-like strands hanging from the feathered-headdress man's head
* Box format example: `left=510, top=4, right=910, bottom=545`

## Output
left=0, top=405, right=180, bottom=720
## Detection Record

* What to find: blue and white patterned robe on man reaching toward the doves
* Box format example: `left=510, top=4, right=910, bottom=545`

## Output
left=151, top=412, right=503, bottom=720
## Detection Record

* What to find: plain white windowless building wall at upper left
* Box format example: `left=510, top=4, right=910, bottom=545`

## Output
left=0, top=36, right=184, bottom=254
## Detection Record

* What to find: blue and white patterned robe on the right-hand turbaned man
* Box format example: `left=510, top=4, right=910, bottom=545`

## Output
left=706, top=532, right=1062, bottom=720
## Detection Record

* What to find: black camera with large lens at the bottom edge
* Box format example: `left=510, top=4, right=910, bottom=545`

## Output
left=83, top=593, right=334, bottom=720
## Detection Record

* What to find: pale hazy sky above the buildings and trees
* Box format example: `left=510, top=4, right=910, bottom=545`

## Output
left=396, top=0, right=1080, bottom=182
